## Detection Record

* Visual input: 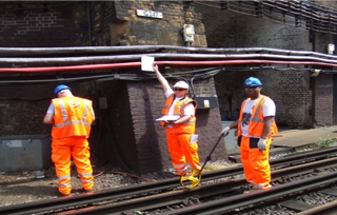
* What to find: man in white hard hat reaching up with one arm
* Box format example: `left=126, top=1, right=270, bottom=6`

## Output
left=154, top=65, right=201, bottom=176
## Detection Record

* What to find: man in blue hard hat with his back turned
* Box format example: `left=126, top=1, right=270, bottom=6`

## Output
left=43, top=84, right=95, bottom=195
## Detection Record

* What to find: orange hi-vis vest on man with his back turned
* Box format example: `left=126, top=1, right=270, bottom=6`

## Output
left=51, top=96, right=94, bottom=138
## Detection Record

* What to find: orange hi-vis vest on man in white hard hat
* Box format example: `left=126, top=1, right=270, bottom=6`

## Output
left=160, top=94, right=197, bottom=134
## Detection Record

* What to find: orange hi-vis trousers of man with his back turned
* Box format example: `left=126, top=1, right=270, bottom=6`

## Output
left=51, top=136, right=94, bottom=195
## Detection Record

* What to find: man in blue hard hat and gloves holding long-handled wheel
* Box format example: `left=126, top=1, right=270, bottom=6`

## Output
left=220, top=77, right=278, bottom=190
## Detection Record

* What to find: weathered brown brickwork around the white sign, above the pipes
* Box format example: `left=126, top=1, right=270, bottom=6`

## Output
left=111, top=1, right=207, bottom=47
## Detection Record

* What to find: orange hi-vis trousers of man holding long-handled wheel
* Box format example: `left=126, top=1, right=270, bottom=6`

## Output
left=240, top=136, right=271, bottom=188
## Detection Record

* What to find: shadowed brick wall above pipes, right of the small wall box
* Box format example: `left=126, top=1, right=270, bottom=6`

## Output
left=196, top=4, right=312, bottom=50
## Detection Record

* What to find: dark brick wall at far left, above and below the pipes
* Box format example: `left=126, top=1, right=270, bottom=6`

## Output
left=0, top=2, right=74, bottom=135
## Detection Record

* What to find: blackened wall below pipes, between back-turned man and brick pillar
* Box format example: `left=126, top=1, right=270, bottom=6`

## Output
left=92, top=81, right=139, bottom=173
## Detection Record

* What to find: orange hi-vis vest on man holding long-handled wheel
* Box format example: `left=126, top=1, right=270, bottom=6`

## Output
left=238, top=95, right=278, bottom=138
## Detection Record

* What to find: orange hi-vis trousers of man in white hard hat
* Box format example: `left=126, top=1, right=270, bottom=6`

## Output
left=166, top=128, right=201, bottom=175
